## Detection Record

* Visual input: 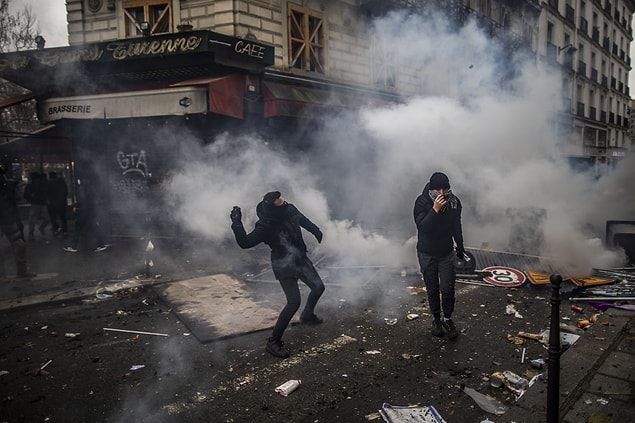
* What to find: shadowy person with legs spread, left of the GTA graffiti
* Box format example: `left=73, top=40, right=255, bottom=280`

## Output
left=64, top=179, right=108, bottom=253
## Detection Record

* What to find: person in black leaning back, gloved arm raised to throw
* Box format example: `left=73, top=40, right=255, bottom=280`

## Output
left=229, top=191, right=324, bottom=358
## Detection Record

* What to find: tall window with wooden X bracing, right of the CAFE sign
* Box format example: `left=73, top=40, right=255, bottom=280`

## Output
left=287, top=4, right=325, bottom=73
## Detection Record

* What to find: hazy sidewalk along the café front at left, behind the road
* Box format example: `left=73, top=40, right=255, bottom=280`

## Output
left=0, top=236, right=236, bottom=310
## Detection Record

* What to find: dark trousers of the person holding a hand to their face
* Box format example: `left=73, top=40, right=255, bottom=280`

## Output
left=417, top=251, right=456, bottom=319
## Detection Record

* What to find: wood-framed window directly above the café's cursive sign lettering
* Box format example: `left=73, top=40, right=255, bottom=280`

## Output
left=123, top=0, right=172, bottom=37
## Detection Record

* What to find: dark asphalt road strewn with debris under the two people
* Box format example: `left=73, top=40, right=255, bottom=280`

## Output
left=0, top=269, right=579, bottom=422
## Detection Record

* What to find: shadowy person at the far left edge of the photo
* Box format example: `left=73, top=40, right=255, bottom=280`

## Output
left=0, top=164, right=35, bottom=278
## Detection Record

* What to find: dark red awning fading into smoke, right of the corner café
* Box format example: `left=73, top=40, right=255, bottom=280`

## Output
left=262, top=81, right=390, bottom=118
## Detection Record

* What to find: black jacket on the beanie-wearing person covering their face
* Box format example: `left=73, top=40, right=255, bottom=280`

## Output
left=413, top=184, right=464, bottom=257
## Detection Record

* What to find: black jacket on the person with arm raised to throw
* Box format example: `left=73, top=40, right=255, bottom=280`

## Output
left=231, top=201, right=322, bottom=279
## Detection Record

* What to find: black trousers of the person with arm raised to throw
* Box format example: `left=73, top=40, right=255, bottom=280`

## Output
left=271, top=257, right=324, bottom=340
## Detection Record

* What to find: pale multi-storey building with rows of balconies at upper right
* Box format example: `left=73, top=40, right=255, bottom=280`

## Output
left=536, top=0, right=635, bottom=174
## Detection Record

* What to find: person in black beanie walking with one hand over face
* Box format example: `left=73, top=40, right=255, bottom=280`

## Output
left=414, top=172, right=469, bottom=339
